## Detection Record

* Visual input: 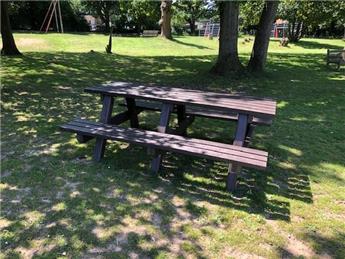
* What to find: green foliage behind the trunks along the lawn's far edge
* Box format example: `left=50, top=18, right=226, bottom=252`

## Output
left=8, top=0, right=345, bottom=39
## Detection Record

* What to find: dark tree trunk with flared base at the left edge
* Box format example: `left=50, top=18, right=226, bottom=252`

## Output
left=0, top=1, right=21, bottom=55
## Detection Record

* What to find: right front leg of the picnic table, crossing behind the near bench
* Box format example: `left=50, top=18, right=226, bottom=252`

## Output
left=226, top=114, right=248, bottom=192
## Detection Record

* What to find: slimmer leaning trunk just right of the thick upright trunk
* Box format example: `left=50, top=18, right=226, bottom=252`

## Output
left=248, top=1, right=279, bottom=72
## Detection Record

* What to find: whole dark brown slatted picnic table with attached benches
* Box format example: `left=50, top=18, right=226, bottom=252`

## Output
left=60, top=82, right=276, bottom=191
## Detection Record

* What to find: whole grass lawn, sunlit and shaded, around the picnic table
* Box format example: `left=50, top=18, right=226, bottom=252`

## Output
left=0, top=34, right=345, bottom=258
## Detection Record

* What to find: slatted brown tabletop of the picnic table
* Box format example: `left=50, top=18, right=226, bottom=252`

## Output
left=85, top=82, right=276, bottom=118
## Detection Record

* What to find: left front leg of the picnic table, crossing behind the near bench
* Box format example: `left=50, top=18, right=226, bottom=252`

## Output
left=93, top=95, right=114, bottom=162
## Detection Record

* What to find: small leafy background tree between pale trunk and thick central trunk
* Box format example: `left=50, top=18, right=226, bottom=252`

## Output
left=176, top=0, right=208, bottom=35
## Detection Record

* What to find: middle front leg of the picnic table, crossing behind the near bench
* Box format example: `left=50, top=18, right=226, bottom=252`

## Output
left=151, top=103, right=173, bottom=174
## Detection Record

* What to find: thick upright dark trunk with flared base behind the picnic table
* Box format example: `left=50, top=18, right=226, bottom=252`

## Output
left=211, top=1, right=243, bottom=75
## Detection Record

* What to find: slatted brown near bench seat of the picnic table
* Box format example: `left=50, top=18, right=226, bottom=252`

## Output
left=60, top=119, right=268, bottom=172
